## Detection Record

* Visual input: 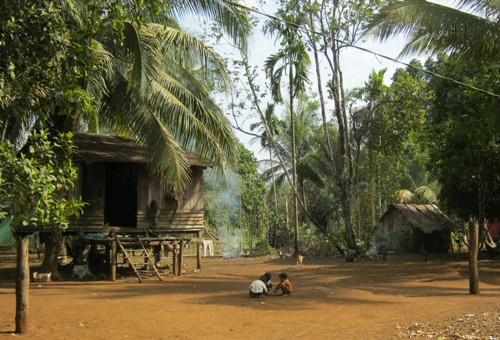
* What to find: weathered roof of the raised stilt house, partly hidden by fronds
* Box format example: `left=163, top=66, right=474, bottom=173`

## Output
left=73, top=133, right=212, bottom=166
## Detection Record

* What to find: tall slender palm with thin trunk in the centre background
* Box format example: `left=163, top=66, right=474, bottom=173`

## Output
left=264, top=10, right=311, bottom=255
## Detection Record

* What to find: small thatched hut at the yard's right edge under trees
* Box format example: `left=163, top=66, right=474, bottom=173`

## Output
left=375, top=204, right=454, bottom=253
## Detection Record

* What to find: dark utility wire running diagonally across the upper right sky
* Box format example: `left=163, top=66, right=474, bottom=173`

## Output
left=222, top=0, right=500, bottom=98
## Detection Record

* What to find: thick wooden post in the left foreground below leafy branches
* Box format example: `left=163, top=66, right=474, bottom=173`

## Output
left=16, top=234, right=30, bottom=334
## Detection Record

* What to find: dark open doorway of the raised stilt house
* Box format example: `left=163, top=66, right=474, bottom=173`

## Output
left=104, top=163, right=137, bottom=228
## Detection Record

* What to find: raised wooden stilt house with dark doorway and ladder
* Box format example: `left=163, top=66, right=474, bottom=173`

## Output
left=64, top=133, right=211, bottom=280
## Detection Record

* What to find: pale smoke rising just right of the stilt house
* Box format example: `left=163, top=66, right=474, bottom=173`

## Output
left=204, top=169, right=243, bottom=258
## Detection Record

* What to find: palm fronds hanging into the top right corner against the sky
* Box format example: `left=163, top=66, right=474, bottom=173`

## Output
left=365, top=0, right=500, bottom=61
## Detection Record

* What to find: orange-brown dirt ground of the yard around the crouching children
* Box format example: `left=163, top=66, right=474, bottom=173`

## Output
left=0, top=251, right=500, bottom=339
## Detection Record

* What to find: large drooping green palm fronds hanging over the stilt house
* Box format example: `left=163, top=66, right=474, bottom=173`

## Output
left=88, top=0, right=252, bottom=193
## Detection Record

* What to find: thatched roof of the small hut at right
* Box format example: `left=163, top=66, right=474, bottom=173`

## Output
left=379, top=204, right=454, bottom=234
